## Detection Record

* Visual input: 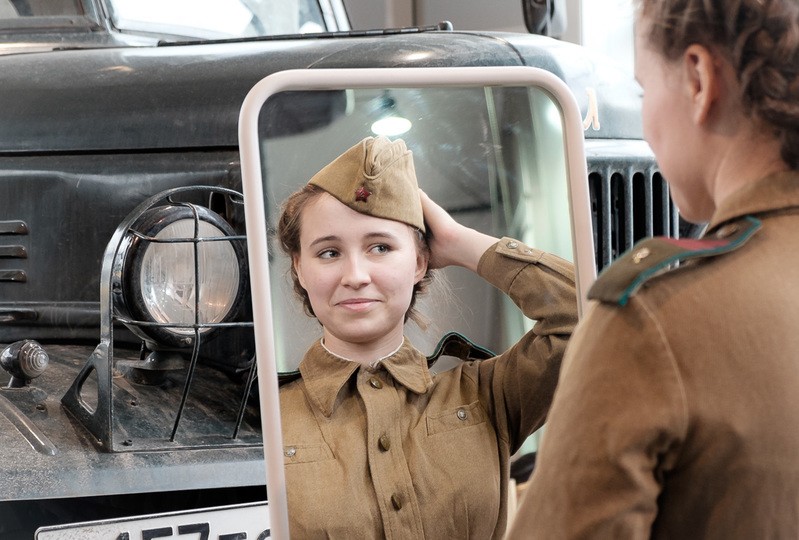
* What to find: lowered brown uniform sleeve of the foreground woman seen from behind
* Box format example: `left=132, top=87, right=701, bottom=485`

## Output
left=509, top=298, right=688, bottom=538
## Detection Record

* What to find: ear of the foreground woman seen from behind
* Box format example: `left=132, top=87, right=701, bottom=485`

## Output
left=683, top=44, right=722, bottom=125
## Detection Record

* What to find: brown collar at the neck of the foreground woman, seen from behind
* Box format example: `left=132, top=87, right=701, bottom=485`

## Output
left=708, top=171, right=799, bottom=233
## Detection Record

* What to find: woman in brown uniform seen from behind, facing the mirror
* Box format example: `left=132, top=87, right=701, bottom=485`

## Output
left=510, top=0, right=799, bottom=539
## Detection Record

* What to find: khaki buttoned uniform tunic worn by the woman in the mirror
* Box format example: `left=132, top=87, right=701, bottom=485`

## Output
left=280, top=238, right=577, bottom=539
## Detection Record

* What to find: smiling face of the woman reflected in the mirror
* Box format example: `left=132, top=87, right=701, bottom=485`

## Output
left=293, top=193, right=427, bottom=352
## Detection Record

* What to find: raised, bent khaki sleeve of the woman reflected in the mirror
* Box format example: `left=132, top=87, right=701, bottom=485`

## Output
left=477, top=238, right=577, bottom=453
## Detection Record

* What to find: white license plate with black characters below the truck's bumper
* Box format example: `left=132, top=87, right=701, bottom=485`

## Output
left=36, top=503, right=269, bottom=540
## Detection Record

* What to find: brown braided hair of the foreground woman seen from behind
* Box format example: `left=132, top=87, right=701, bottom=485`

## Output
left=636, top=0, right=799, bottom=169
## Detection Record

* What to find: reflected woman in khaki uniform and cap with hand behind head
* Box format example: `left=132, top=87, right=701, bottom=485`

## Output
left=278, top=137, right=577, bottom=539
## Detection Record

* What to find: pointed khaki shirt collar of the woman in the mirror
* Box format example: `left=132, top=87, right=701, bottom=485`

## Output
left=300, top=338, right=433, bottom=417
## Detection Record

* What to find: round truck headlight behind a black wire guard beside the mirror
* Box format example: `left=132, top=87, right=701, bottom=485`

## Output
left=114, top=205, right=246, bottom=346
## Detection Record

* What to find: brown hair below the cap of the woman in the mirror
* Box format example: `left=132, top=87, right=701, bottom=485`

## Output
left=277, top=184, right=434, bottom=329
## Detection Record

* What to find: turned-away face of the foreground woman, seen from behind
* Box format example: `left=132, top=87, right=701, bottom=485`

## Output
left=635, top=17, right=714, bottom=222
